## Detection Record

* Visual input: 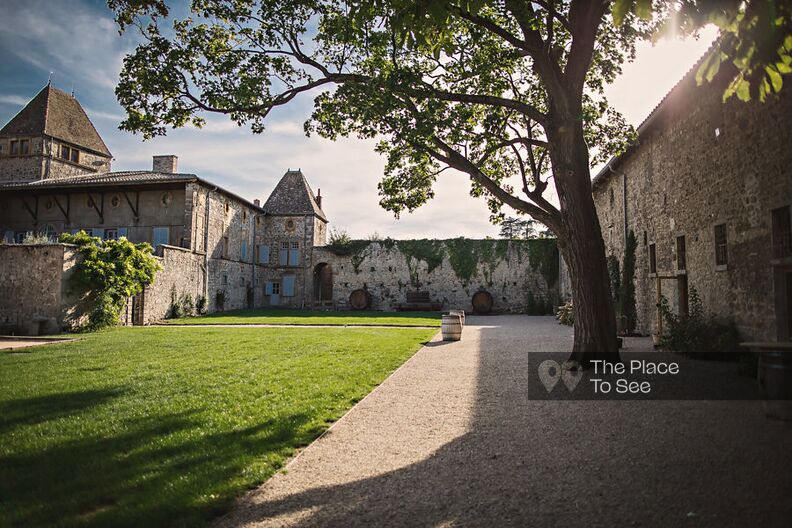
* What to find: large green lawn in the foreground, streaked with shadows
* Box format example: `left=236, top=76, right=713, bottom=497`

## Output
left=0, top=327, right=435, bottom=526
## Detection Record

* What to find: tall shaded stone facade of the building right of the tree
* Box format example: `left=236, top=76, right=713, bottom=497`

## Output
left=593, top=63, right=792, bottom=340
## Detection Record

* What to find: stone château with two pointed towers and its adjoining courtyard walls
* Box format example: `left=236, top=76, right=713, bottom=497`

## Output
left=0, top=86, right=559, bottom=333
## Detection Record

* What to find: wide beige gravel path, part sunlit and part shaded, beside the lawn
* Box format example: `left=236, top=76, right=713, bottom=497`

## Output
left=218, top=316, right=792, bottom=527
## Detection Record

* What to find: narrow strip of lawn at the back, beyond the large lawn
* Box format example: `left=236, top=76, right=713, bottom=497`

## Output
left=163, top=308, right=441, bottom=327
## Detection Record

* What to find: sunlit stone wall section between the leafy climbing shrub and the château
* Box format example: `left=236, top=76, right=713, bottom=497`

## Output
left=141, top=246, right=206, bottom=324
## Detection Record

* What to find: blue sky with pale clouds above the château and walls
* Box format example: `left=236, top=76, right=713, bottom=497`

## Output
left=0, top=0, right=715, bottom=238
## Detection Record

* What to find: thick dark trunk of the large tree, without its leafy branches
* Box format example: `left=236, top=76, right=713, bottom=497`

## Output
left=551, top=121, right=621, bottom=368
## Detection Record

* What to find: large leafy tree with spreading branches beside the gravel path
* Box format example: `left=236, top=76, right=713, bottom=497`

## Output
left=110, top=0, right=788, bottom=363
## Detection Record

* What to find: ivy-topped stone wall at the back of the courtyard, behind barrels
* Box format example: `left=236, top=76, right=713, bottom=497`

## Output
left=312, top=239, right=560, bottom=313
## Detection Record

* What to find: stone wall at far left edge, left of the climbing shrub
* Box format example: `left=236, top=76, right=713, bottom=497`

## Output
left=0, top=244, right=80, bottom=335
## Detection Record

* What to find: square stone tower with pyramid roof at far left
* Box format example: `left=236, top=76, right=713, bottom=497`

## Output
left=0, top=85, right=112, bottom=182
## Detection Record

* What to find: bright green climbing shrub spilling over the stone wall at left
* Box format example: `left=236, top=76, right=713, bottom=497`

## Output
left=60, top=231, right=161, bottom=331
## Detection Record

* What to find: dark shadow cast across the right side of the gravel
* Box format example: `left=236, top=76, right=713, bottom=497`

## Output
left=219, top=322, right=792, bottom=527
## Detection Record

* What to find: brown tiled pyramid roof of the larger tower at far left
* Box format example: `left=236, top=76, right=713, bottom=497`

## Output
left=0, top=84, right=112, bottom=157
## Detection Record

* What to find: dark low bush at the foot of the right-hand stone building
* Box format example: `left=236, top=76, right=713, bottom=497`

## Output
left=659, top=287, right=740, bottom=358
